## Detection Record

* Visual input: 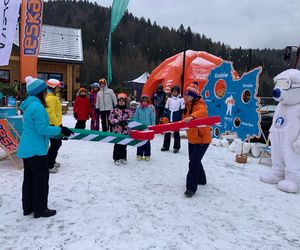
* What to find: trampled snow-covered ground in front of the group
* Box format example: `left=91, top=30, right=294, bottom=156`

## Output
left=0, top=114, right=300, bottom=250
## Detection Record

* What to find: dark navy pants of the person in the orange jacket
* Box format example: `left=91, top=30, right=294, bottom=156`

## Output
left=186, top=143, right=209, bottom=192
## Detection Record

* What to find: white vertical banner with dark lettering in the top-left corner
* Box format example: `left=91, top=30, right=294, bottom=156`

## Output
left=0, top=0, right=20, bottom=66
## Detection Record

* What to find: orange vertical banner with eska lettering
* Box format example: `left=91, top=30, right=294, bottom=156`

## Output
left=20, top=0, right=43, bottom=83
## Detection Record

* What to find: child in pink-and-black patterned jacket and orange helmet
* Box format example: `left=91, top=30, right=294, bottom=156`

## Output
left=109, top=93, right=132, bottom=166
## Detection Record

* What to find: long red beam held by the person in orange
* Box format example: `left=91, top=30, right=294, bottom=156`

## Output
left=130, top=116, right=221, bottom=140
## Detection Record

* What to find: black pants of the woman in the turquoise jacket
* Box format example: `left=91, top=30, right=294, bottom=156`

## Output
left=22, top=155, right=49, bottom=212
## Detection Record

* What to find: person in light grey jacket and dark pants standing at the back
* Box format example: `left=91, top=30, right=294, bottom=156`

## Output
left=96, top=78, right=117, bottom=132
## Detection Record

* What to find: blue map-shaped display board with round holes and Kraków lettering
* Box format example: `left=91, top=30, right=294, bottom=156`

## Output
left=202, top=61, right=262, bottom=140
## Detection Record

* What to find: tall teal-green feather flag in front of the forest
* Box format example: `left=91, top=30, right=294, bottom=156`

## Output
left=107, top=0, right=129, bottom=84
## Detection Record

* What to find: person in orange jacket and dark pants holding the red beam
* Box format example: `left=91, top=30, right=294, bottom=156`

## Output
left=183, top=82, right=212, bottom=197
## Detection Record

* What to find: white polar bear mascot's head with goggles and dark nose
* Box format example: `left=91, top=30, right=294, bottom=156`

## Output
left=272, top=69, right=300, bottom=105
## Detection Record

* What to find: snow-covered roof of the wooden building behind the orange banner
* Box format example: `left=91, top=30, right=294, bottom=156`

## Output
left=14, top=24, right=83, bottom=63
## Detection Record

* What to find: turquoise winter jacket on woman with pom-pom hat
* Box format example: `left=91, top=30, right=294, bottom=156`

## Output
left=17, top=96, right=61, bottom=158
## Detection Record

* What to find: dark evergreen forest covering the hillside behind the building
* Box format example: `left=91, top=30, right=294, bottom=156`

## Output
left=43, top=0, right=298, bottom=96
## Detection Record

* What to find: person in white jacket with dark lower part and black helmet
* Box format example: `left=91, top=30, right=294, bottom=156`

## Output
left=161, top=86, right=185, bottom=153
